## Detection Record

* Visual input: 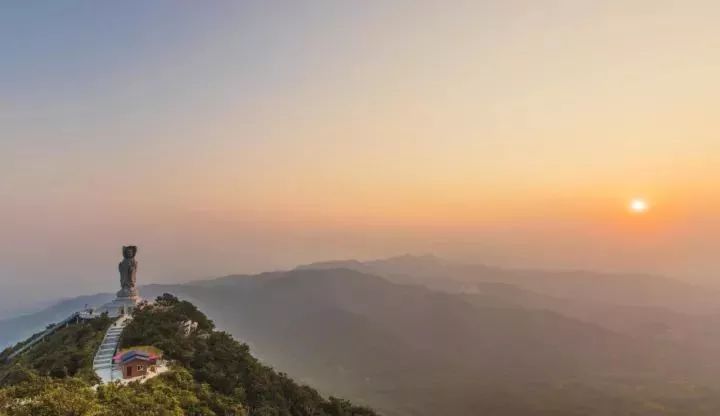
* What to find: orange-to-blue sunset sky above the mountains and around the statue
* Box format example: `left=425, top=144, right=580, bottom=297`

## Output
left=0, top=0, right=720, bottom=316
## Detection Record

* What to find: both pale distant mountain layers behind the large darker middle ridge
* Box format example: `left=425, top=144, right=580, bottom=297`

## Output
left=298, top=255, right=720, bottom=344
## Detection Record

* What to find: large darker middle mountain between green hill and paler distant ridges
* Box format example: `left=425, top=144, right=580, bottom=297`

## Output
left=138, top=269, right=720, bottom=416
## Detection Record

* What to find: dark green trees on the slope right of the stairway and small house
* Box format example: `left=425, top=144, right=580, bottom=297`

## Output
left=116, top=294, right=374, bottom=416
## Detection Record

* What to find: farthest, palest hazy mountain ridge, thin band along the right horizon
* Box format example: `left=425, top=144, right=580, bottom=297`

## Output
left=298, top=255, right=720, bottom=313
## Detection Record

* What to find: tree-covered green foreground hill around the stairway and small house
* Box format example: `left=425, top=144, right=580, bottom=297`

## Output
left=0, top=295, right=375, bottom=416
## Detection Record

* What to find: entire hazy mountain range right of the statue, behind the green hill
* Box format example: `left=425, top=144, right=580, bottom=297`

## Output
left=4, top=256, right=720, bottom=416
